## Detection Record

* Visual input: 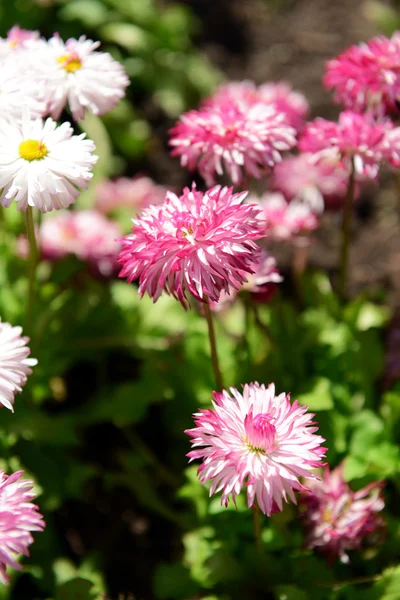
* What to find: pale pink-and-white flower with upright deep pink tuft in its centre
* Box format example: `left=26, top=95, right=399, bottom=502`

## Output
left=185, top=383, right=325, bottom=516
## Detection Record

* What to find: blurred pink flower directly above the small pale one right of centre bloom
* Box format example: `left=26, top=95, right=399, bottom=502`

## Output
left=272, top=154, right=349, bottom=213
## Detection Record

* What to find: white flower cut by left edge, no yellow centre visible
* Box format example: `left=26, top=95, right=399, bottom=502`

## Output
left=0, top=321, right=37, bottom=412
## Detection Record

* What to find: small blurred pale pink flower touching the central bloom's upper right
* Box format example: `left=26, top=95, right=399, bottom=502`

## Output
left=249, top=193, right=319, bottom=240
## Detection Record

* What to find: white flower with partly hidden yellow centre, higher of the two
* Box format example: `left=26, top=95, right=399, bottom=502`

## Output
left=33, top=35, right=129, bottom=121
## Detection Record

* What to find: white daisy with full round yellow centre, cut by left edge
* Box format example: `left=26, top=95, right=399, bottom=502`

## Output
left=0, top=118, right=97, bottom=212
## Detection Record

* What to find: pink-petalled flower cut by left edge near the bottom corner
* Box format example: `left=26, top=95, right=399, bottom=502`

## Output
left=0, top=470, right=45, bottom=584
